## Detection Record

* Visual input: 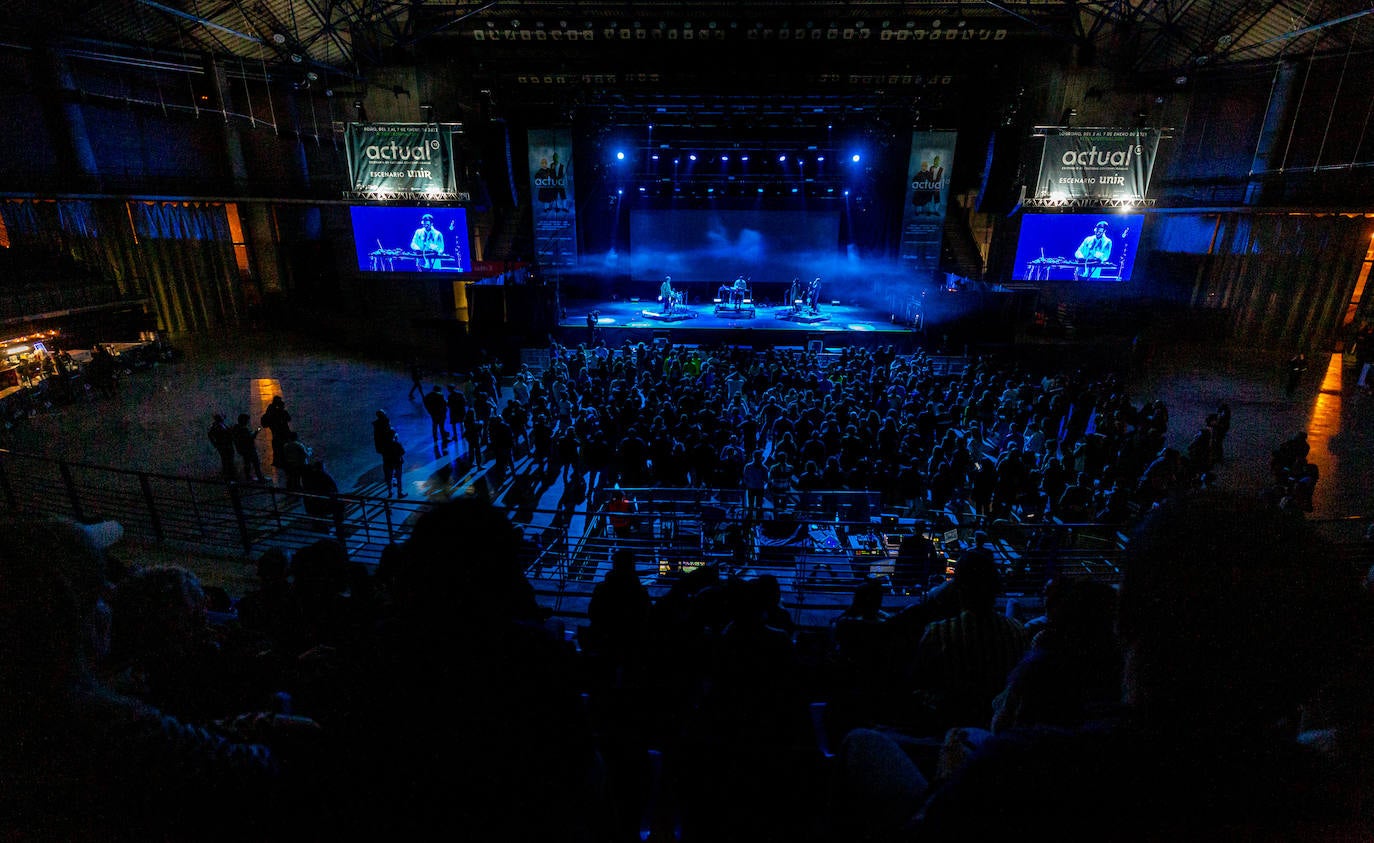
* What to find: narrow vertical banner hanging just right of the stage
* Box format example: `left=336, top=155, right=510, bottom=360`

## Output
left=901, top=132, right=958, bottom=277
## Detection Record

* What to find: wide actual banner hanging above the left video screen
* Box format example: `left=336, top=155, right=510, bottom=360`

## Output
left=344, top=124, right=471, bottom=202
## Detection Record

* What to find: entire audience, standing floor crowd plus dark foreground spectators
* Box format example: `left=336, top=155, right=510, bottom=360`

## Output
left=10, top=345, right=1374, bottom=842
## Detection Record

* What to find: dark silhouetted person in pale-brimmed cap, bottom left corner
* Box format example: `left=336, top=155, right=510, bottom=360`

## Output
left=0, top=516, right=286, bottom=840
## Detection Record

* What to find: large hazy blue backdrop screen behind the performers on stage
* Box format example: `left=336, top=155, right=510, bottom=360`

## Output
left=629, top=210, right=840, bottom=283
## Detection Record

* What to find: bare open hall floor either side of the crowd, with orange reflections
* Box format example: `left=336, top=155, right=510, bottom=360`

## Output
left=4, top=326, right=1374, bottom=598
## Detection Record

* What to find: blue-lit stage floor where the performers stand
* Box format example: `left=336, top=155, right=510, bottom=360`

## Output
left=559, top=299, right=918, bottom=346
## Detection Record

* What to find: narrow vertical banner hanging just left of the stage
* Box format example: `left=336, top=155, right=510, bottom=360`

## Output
left=529, top=129, right=577, bottom=266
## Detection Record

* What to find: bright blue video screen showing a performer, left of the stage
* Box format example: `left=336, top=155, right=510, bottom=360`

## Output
left=349, top=205, right=473, bottom=272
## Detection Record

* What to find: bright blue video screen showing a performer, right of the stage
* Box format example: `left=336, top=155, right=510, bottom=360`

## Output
left=1011, top=213, right=1145, bottom=281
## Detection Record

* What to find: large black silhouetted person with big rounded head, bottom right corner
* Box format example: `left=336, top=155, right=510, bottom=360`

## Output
left=919, top=494, right=1369, bottom=840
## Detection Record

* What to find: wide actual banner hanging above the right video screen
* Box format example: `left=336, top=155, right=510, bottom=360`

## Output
left=1035, top=129, right=1160, bottom=199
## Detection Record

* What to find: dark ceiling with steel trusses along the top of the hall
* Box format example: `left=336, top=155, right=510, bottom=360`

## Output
left=8, top=0, right=1374, bottom=78
